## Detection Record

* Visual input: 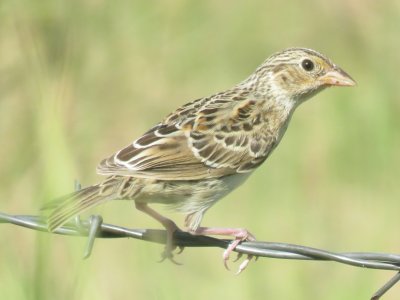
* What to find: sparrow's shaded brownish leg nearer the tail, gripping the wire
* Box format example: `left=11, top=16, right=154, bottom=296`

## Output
left=135, top=201, right=179, bottom=265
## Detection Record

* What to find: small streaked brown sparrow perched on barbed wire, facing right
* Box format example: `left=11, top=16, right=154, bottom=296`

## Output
left=47, top=47, right=356, bottom=272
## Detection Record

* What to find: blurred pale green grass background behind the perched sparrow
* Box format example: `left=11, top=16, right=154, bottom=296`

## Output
left=0, top=0, right=400, bottom=300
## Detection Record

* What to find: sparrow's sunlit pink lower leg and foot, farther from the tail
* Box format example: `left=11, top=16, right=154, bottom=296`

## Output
left=189, top=227, right=256, bottom=274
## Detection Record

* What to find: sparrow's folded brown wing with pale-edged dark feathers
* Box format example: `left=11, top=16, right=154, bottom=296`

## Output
left=97, top=93, right=276, bottom=180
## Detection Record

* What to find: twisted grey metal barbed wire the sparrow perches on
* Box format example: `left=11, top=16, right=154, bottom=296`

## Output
left=0, top=212, right=400, bottom=300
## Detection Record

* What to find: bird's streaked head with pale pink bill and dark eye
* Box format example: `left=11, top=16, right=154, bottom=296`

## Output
left=250, top=48, right=356, bottom=104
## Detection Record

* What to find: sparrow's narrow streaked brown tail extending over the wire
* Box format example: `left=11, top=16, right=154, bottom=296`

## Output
left=42, top=177, right=138, bottom=231
